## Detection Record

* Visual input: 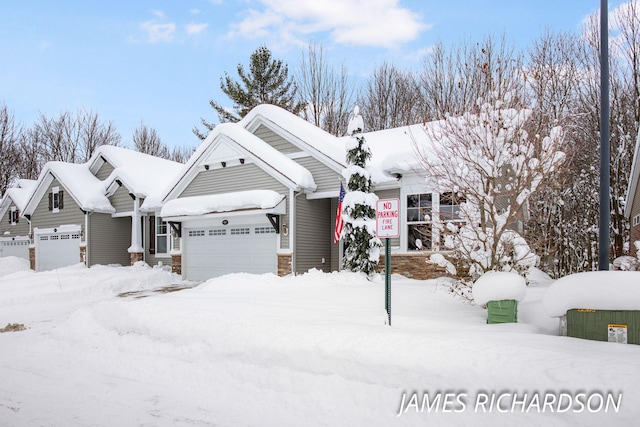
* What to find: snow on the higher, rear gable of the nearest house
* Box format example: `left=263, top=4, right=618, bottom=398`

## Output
left=238, top=104, right=346, bottom=167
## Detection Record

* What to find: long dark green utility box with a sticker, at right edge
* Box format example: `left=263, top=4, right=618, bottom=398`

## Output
left=567, top=309, right=640, bottom=344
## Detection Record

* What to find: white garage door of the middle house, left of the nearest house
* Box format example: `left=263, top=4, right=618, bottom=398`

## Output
left=34, top=226, right=80, bottom=271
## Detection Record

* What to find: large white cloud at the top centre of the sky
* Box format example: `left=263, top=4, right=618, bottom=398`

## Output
left=229, top=0, right=428, bottom=47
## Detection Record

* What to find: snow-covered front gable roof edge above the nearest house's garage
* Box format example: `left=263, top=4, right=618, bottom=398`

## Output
left=150, top=123, right=316, bottom=210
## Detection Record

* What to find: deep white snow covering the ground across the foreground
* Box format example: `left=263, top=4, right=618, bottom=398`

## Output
left=0, top=258, right=640, bottom=426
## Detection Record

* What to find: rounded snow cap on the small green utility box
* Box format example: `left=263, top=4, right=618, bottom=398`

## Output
left=473, top=271, right=527, bottom=305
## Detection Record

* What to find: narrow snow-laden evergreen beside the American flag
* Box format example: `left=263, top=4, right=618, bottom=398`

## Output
left=343, top=107, right=382, bottom=276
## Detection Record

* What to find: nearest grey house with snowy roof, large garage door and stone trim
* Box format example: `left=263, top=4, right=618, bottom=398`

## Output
left=151, top=105, right=456, bottom=280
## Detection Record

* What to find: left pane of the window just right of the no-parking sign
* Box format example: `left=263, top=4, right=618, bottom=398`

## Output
left=407, top=193, right=432, bottom=251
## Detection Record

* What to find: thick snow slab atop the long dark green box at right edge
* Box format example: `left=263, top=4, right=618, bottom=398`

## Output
left=542, top=271, right=640, bottom=317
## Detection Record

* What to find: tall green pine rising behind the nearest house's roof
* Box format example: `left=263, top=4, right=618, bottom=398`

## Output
left=193, top=46, right=303, bottom=139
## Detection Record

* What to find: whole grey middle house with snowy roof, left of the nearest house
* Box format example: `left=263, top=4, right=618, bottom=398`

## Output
left=22, top=146, right=182, bottom=271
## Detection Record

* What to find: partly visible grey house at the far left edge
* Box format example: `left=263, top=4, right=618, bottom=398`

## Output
left=0, top=179, right=36, bottom=259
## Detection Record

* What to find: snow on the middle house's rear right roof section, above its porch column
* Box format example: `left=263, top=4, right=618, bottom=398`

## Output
left=89, top=145, right=184, bottom=197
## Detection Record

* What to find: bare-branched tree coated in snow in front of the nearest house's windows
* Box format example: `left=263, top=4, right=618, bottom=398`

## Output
left=416, top=94, right=565, bottom=278
